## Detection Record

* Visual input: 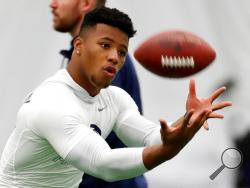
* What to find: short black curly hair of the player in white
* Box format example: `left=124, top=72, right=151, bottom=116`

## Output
left=80, top=7, right=136, bottom=38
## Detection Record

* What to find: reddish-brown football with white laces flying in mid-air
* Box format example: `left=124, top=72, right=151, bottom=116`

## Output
left=134, top=30, right=216, bottom=78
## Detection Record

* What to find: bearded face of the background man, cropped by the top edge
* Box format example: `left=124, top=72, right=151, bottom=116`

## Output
left=50, top=0, right=83, bottom=32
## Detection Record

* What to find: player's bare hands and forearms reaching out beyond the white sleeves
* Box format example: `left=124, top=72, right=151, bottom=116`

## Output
left=143, top=80, right=232, bottom=169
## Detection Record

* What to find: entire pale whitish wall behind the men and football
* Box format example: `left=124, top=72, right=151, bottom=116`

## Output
left=0, top=0, right=250, bottom=188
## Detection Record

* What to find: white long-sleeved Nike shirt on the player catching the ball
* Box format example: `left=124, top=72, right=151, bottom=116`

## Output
left=0, top=69, right=161, bottom=188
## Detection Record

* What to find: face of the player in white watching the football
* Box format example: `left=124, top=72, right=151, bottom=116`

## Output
left=75, top=24, right=128, bottom=93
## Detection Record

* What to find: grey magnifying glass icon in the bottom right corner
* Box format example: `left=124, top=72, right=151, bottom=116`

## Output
left=209, top=148, right=243, bottom=180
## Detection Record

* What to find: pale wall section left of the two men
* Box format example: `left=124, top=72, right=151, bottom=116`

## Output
left=0, top=0, right=69, bottom=151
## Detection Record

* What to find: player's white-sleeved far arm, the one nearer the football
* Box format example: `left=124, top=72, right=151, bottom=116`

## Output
left=113, top=88, right=160, bottom=147
